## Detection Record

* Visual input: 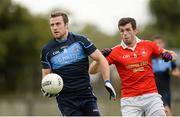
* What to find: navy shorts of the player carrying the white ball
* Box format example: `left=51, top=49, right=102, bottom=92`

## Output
left=56, top=89, right=100, bottom=116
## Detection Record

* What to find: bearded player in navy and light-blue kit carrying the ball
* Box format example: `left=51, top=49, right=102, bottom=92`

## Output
left=41, top=11, right=114, bottom=116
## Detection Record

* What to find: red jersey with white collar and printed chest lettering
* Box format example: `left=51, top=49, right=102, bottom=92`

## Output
left=106, top=39, right=163, bottom=97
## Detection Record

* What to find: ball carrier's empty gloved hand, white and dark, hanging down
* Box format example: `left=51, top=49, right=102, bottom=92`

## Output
left=104, top=80, right=116, bottom=100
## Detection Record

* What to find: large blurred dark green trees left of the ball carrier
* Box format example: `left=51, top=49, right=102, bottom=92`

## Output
left=0, top=0, right=50, bottom=93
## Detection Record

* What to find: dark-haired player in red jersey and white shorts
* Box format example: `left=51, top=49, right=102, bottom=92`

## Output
left=89, top=18, right=177, bottom=116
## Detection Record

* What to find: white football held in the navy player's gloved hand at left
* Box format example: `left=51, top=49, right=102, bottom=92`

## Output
left=41, top=73, right=63, bottom=94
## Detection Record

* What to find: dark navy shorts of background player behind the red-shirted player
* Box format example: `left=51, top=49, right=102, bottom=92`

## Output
left=159, top=91, right=171, bottom=107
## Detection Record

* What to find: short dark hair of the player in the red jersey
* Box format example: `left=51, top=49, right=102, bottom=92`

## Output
left=118, top=17, right=136, bottom=29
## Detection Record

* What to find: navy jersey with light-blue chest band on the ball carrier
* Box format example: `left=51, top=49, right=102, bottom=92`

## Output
left=41, top=32, right=96, bottom=94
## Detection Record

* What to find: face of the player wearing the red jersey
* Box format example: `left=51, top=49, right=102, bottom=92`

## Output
left=119, top=23, right=137, bottom=46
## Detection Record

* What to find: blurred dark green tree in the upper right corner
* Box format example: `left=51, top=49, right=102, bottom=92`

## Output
left=142, top=0, right=180, bottom=48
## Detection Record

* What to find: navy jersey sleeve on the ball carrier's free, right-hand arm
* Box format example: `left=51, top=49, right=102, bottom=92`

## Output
left=79, top=36, right=97, bottom=55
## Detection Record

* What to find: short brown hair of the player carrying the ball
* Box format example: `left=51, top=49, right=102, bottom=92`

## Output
left=50, top=11, right=69, bottom=24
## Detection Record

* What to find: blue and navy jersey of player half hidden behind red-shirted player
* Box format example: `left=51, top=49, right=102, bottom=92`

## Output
left=152, top=58, right=177, bottom=92
